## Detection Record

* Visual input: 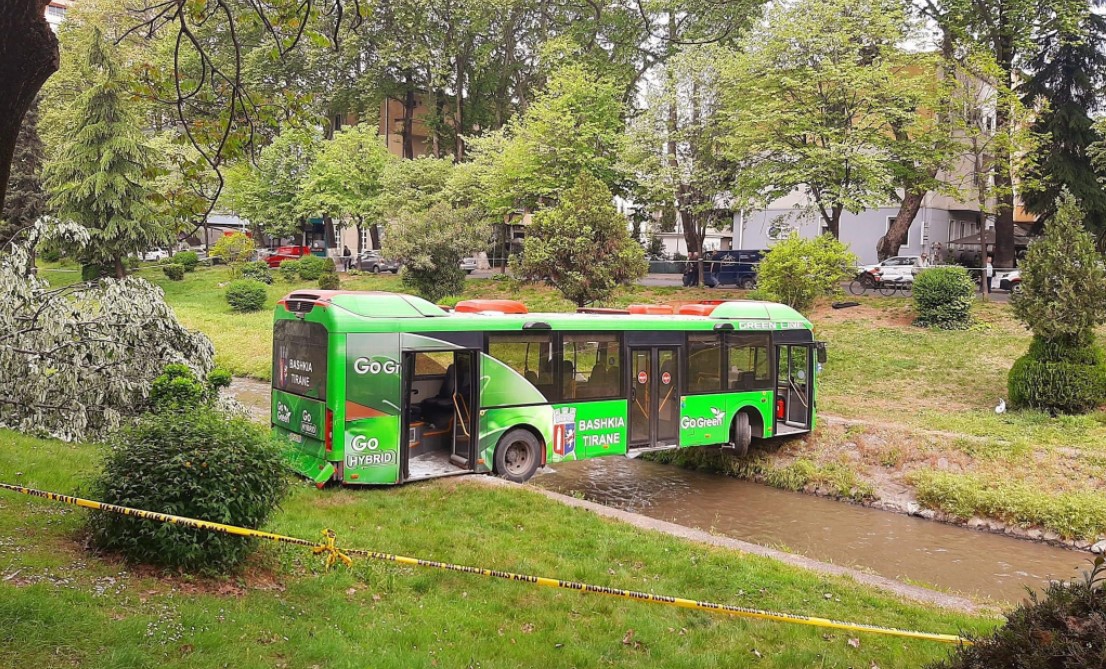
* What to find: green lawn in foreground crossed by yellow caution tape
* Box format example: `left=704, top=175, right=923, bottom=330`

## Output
left=0, top=432, right=995, bottom=668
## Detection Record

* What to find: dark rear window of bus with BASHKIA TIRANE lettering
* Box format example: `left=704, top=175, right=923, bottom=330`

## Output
left=273, top=320, right=327, bottom=399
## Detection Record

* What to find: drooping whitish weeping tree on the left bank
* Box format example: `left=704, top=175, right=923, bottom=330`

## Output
left=0, top=221, right=215, bottom=440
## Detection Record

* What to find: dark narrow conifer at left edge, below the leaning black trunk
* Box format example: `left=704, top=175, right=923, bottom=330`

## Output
left=0, top=96, right=46, bottom=251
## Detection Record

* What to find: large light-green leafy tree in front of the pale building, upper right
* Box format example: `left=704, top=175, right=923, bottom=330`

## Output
left=721, top=0, right=951, bottom=237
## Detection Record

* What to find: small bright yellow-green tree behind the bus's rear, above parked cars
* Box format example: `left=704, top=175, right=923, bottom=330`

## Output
left=300, top=125, right=392, bottom=253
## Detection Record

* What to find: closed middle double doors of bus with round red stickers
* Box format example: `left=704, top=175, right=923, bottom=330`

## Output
left=629, top=346, right=680, bottom=448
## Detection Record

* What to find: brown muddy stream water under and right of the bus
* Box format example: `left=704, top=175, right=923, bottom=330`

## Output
left=531, top=458, right=1088, bottom=602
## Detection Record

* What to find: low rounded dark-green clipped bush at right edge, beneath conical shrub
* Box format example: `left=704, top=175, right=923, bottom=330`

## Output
left=1006, top=336, right=1106, bottom=414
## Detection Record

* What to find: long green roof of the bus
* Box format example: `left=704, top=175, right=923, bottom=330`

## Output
left=275, top=290, right=812, bottom=332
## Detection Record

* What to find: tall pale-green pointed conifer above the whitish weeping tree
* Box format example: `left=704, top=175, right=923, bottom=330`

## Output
left=44, top=29, right=169, bottom=278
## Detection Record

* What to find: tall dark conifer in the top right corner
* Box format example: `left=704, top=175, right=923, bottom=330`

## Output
left=1022, top=8, right=1106, bottom=245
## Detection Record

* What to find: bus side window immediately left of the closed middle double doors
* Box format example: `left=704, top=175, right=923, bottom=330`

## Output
left=561, top=333, right=623, bottom=401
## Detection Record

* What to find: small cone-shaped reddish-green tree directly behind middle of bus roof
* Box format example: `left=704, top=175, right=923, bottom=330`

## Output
left=517, top=171, right=649, bottom=306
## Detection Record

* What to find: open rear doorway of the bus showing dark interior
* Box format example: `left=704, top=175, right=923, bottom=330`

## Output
left=400, top=349, right=479, bottom=481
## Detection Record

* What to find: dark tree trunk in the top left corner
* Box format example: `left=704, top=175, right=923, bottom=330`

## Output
left=0, top=0, right=60, bottom=211
